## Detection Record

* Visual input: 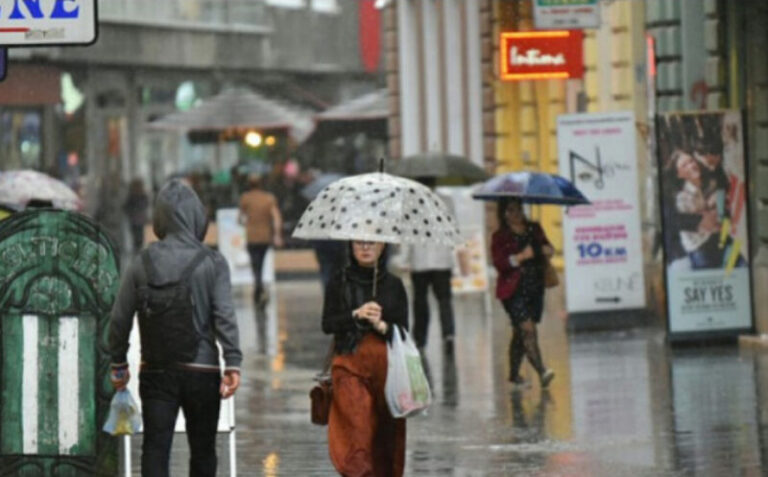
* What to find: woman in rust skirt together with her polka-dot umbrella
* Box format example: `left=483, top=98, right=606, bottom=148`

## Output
left=293, top=167, right=458, bottom=477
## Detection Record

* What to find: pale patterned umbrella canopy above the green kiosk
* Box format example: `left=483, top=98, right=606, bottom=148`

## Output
left=0, top=169, right=82, bottom=210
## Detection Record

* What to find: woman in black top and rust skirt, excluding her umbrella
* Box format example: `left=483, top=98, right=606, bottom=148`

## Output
left=323, top=241, right=408, bottom=477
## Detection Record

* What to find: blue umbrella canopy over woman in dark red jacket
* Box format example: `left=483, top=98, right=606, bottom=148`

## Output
left=472, top=172, right=589, bottom=205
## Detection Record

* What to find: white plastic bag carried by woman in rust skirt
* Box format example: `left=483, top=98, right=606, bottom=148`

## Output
left=384, top=326, right=432, bottom=417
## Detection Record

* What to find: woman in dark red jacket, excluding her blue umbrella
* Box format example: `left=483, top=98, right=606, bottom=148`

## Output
left=491, top=199, right=555, bottom=388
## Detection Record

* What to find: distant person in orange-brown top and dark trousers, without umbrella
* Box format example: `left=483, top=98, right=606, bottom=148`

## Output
left=240, top=175, right=283, bottom=306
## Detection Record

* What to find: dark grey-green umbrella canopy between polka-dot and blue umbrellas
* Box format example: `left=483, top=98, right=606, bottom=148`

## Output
left=392, top=152, right=488, bottom=182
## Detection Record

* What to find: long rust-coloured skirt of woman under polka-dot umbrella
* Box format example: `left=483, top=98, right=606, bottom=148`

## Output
left=328, top=333, right=405, bottom=477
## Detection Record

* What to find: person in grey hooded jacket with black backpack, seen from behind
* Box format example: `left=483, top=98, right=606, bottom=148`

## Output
left=109, top=180, right=242, bottom=477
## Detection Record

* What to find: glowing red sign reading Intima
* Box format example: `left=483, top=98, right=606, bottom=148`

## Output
left=500, top=30, right=584, bottom=81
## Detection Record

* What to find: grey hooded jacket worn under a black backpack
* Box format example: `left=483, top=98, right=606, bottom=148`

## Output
left=109, top=180, right=242, bottom=371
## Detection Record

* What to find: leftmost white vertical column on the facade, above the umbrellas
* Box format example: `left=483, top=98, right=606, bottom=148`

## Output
left=397, top=0, right=421, bottom=156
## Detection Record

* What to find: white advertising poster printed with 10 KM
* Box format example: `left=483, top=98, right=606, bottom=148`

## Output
left=557, top=112, right=645, bottom=313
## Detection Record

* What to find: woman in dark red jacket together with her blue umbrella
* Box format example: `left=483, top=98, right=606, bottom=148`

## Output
left=472, top=172, right=589, bottom=388
